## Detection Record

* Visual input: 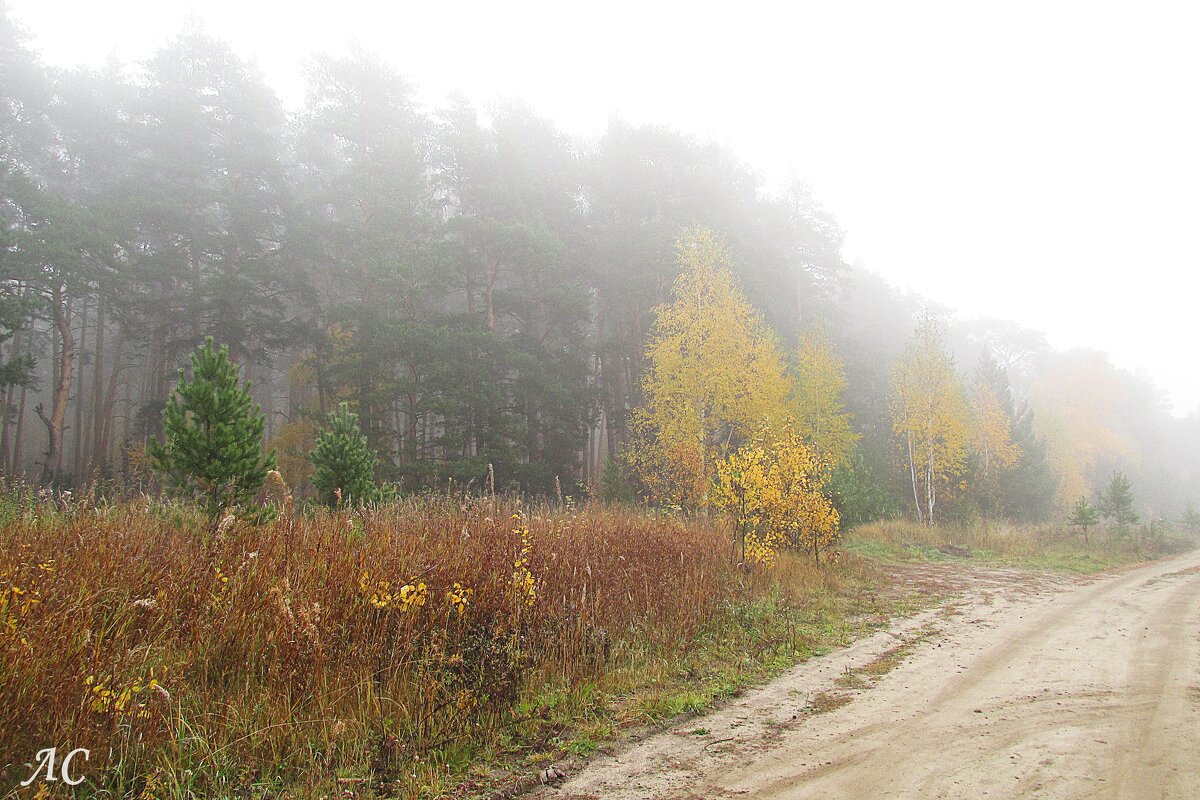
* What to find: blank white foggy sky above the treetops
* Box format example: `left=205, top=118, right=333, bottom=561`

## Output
left=10, top=0, right=1200, bottom=414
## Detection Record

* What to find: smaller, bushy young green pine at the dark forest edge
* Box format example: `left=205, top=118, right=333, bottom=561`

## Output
left=308, top=403, right=380, bottom=506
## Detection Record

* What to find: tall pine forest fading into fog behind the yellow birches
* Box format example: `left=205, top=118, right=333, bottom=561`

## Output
left=0, top=6, right=1200, bottom=522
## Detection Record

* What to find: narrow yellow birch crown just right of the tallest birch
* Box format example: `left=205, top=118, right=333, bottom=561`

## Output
left=792, top=330, right=859, bottom=468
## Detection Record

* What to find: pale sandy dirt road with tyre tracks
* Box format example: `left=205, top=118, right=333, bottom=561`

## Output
left=539, top=553, right=1200, bottom=800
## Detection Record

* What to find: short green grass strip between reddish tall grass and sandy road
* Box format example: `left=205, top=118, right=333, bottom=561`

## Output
left=468, top=554, right=932, bottom=790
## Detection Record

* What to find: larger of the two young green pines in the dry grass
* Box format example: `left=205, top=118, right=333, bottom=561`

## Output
left=148, top=337, right=275, bottom=522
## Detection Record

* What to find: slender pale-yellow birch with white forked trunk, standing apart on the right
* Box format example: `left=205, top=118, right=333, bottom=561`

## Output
left=892, top=317, right=967, bottom=525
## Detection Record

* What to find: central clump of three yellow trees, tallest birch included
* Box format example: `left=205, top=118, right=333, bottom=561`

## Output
left=626, top=229, right=856, bottom=565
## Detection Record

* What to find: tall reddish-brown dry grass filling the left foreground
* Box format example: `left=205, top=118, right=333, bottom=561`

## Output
left=0, top=498, right=768, bottom=796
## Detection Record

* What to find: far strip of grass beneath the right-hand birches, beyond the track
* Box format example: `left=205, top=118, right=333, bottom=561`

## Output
left=845, top=521, right=1195, bottom=573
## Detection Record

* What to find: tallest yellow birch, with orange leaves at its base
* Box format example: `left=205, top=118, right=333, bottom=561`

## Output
left=626, top=228, right=791, bottom=507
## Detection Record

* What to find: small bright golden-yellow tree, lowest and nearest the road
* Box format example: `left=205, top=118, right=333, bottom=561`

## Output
left=712, top=422, right=840, bottom=566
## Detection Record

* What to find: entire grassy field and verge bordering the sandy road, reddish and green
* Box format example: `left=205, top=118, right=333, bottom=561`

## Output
left=0, top=498, right=1174, bottom=800
